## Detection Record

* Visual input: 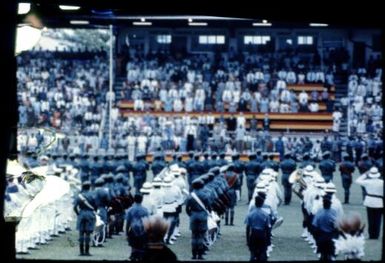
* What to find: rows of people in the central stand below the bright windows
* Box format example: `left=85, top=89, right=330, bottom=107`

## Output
left=119, top=52, right=334, bottom=112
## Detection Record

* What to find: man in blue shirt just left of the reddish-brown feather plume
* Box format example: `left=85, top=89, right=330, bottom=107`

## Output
left=126, top=193, right=149, bottom=261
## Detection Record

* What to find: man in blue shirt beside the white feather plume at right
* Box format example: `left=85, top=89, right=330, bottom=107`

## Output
left=312, top=195, right=338, bottom=261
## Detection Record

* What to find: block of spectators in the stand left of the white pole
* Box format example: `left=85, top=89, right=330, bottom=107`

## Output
left=17, top=51, right=108, bottom=154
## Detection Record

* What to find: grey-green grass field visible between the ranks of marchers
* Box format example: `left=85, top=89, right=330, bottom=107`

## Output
left=18, top=167, right=383, bottom=261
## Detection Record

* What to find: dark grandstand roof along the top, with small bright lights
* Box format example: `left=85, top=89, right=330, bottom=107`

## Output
left=21, top=0, right=382, bottom=28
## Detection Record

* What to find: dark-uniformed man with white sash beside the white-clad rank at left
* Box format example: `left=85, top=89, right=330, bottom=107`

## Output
left=73, top=181, right=97, bottom=256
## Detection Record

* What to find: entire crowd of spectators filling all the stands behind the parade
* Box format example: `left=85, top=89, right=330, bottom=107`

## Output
left=17, top=46, right=382, bottom=164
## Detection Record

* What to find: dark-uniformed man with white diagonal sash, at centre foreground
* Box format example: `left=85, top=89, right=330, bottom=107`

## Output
left=186, top=179, right=211, bottom=259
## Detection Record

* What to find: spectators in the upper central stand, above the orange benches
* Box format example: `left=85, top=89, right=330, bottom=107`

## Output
left=117, top=49, right=334, bottom=113
